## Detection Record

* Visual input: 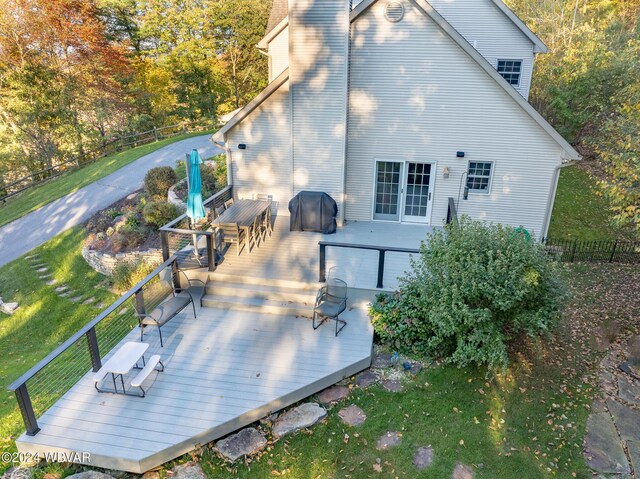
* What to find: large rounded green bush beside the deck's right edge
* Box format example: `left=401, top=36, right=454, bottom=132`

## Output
left=370, top=218, right=565, bottom=368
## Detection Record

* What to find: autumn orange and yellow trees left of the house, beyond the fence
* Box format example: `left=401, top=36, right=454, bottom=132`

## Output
left=0, top=0, right=271, bottom=188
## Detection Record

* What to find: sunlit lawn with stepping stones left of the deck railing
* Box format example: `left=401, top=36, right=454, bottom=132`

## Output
left=0, top=227, right=115, bottom=472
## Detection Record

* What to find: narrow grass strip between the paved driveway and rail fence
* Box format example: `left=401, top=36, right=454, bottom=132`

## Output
left=0, top=131, right=212, bottom=226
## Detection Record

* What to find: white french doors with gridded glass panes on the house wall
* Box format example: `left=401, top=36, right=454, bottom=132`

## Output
left=373, top=161, right=435, bottom=223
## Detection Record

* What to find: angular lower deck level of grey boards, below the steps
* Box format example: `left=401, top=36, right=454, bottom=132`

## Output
left=16, top=292, right=373, bottom=473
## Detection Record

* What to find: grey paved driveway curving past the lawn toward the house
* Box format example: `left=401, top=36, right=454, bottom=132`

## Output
left=0, top=135, right=222, bottom=266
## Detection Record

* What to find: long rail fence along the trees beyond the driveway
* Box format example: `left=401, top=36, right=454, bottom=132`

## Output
left=0, top=122, right=213, bottom=206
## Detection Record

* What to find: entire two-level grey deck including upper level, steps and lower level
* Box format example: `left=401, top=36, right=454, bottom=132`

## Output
left=16, top=217, right=431, bottom=473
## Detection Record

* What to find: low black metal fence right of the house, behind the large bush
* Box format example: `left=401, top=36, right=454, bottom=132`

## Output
left=542, top=238, right=640, bottom=263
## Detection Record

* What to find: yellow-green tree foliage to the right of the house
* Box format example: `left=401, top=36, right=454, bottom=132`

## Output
left=507, top=0, right=640, bottom=232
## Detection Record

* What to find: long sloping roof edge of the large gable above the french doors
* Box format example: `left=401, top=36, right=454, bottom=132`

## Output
left=350, top=0, right=582, bottom=160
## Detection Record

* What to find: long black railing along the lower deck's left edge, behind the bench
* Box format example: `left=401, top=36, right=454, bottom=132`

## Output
left=8, top=257, right=178, bottom=436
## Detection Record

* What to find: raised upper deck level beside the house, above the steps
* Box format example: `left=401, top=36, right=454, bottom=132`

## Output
left=211, top=216, right=434, bottom=290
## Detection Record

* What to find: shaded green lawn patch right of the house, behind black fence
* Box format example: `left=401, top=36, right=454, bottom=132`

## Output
left=549, top=165, right=632, bottom=241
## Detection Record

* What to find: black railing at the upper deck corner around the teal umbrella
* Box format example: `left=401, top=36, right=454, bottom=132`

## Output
left=160, top=186, right=233, bottom=271
